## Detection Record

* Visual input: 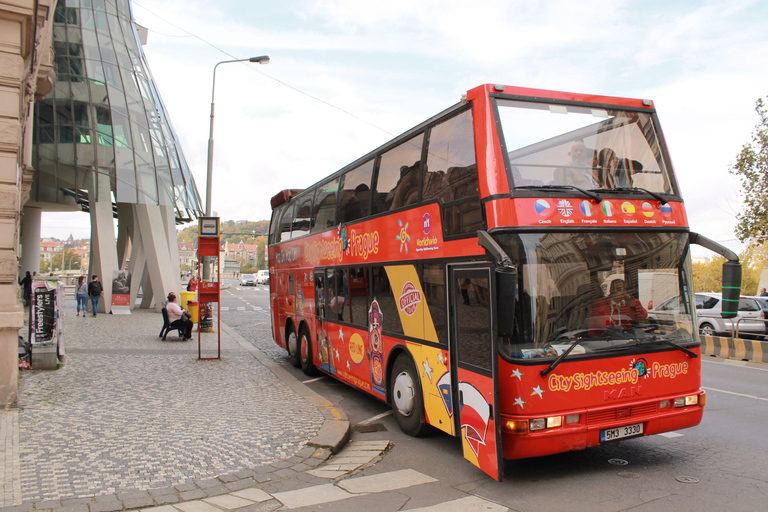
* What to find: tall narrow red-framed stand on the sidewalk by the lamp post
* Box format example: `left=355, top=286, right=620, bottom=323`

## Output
left=197, top=217, right=221, bottom=359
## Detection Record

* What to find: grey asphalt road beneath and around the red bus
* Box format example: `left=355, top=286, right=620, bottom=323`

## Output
left=221, top=281, right=768, bottom=512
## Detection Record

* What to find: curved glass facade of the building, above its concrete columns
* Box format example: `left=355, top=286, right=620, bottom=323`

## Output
left=30, top=0, right=202, bottom=222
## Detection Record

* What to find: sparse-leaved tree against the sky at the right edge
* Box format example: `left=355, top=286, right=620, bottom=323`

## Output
left=729, top=97, right=768, bottom=243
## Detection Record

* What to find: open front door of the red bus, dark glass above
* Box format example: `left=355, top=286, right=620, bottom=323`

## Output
left=449, top=264, right=503, bottom=481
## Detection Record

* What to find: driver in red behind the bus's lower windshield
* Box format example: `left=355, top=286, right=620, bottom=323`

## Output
left=589, top=274, right=648, bottom=336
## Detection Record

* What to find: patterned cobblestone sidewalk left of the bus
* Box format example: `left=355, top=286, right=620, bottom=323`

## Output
left=0, top=303, right=344, bottom=512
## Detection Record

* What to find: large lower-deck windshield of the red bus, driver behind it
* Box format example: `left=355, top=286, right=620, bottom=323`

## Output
left=495, top=232, right=698, bottom=359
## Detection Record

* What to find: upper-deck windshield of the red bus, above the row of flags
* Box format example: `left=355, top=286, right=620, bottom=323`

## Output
left=497, top=100, right=675, bottom=194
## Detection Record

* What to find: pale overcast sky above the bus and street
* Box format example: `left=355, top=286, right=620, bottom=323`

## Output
left=42, top=0, right=768, bottom=256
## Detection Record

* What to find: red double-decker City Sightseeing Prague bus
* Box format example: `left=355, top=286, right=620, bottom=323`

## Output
left=269, top=85, right=740, bottom=480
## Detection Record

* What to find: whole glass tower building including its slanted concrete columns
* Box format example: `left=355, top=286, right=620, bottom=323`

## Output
left=21, top=0, right=202, bottom=311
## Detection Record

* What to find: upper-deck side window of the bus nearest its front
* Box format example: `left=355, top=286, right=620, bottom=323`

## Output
left=421, top=110, right=478, bottom=203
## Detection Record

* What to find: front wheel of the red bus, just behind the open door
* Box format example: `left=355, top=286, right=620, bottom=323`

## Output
left=391, top=354, right=429, bottom=437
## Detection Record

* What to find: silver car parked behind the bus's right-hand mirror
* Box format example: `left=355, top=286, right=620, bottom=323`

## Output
left=696, top=293, right=765, bottom=336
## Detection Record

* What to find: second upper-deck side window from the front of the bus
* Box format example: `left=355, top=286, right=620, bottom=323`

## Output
left=373, top=133, right=424, bottom=214
